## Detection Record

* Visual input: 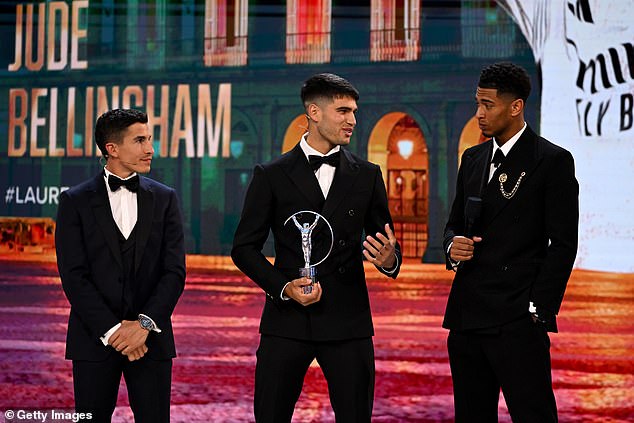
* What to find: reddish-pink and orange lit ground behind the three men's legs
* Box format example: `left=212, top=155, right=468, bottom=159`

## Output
left=0, top=257, right=634, bottom=423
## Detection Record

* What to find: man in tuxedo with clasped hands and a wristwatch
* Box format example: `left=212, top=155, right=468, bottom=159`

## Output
left=55, top=109, right=185, bottom=423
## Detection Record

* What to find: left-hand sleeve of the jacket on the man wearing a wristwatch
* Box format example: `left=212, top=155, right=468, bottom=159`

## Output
left=55, top=191, right=120, bottom=340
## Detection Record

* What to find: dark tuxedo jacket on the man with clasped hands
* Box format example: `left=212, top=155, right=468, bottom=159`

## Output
left=55, top=173, right=185, bottom=361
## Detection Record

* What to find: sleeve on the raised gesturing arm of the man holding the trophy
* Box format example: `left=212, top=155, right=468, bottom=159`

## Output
left=364, top=166, right=403, bottom=279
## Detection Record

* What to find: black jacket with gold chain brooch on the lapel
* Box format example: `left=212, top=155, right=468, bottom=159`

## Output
left=443, top=127, right=579, bottom=331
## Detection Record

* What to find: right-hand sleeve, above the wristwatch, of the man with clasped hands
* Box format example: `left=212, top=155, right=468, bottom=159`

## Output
left=141, top=190, right=186, bottom=327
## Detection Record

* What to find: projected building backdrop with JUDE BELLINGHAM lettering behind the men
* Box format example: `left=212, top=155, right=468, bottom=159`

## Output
left=0, top=0, right=634, bottom=272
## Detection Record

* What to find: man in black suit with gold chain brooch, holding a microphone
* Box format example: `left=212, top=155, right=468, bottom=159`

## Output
left=443, top=63, right=579, bottom=423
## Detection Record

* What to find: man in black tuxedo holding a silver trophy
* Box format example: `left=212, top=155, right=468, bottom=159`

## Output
left=231, top=74, right=401, bottom=423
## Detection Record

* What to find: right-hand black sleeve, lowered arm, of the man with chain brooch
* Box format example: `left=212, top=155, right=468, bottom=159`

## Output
left=531, top=150, right=579, bottom=314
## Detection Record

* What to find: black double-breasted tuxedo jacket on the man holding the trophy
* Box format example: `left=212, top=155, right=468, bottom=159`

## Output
left=231, top=144, right=401, bottom=341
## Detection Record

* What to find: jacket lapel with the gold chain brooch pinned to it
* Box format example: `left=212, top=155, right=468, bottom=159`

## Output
left=482, top=128, right=539, bottom=227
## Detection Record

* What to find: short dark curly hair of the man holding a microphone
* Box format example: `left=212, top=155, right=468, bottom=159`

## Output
left=478, top=62, right=531, bottom=101
